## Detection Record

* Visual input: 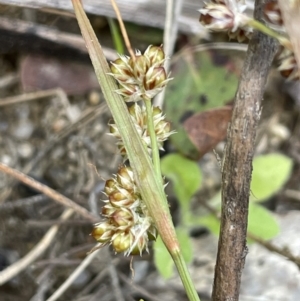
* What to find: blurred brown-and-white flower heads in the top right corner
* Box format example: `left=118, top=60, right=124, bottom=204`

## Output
left=199, top=0, right=300, bottom=80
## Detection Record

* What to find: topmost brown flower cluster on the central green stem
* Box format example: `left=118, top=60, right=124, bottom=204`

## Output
left=110, top=45, right=170, bottom=102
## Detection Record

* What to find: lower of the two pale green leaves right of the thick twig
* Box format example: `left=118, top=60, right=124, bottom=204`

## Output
left=248, top=202, right=280, bottom=240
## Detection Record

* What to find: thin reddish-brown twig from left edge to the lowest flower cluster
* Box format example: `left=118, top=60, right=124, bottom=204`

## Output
left=0, top=163, right=98, bottom=222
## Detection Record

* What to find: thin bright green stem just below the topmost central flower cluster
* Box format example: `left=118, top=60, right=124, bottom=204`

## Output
left=143, top=96, right=162, bottom=183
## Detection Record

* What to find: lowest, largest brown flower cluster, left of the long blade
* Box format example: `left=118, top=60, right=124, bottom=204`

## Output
left=92, top=166, right=157, bottom=255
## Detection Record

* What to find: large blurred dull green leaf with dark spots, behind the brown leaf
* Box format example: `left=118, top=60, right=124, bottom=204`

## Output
left=165, top=52, right=237, bottom=158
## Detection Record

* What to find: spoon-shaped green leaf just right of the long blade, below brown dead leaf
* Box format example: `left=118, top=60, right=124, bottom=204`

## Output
left=161, top=154, right=202, bottom=214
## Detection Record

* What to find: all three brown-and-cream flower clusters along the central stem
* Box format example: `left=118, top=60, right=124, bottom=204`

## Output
left=92, top=46, right=173, bottom=255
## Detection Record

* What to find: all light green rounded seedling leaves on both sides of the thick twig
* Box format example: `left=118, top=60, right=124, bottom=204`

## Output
left=154, top=154, right=292, bottom=278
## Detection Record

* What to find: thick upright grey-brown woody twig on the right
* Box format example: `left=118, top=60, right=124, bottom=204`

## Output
left=212, top=0, right=277, bottom=301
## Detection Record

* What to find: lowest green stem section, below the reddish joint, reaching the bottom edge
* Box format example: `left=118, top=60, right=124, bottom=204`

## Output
left=171, top=251, right=200, bottom=301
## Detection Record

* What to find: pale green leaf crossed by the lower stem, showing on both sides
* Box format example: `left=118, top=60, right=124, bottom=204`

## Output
left=154, top=227, right=193, bottom=279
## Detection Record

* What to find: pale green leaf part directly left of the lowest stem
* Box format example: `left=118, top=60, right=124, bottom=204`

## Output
left=154, top=236, right=174, bottom=279
